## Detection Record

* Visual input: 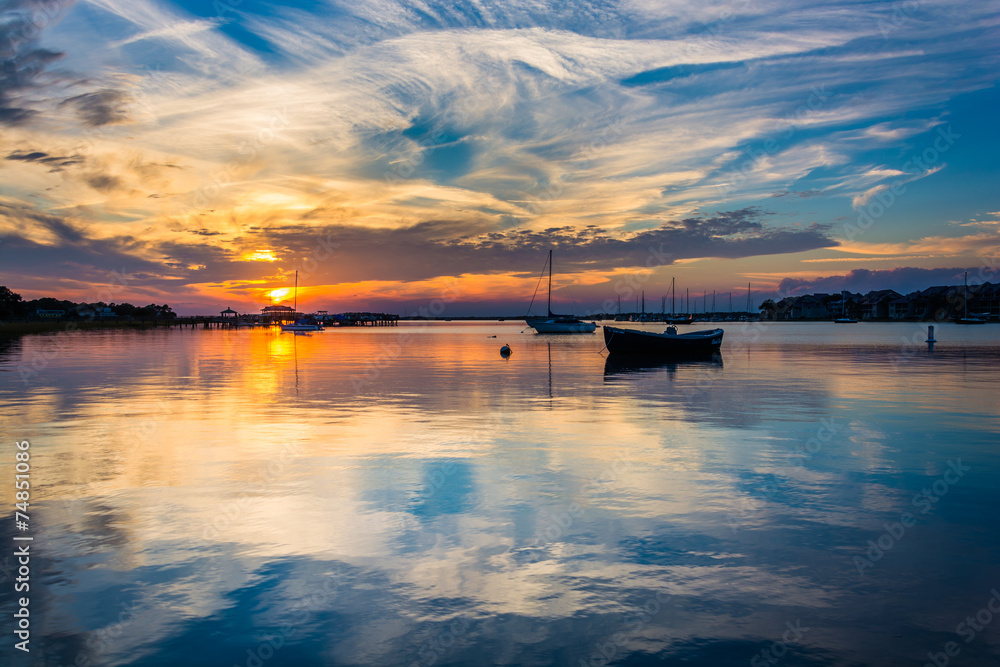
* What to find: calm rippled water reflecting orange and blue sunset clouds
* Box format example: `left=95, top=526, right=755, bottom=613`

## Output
left=0, top=322, right=1000, bottom=667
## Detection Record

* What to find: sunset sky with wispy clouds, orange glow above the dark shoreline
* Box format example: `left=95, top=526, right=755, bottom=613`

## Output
left=0, top=0, right=1000, bottom=316
